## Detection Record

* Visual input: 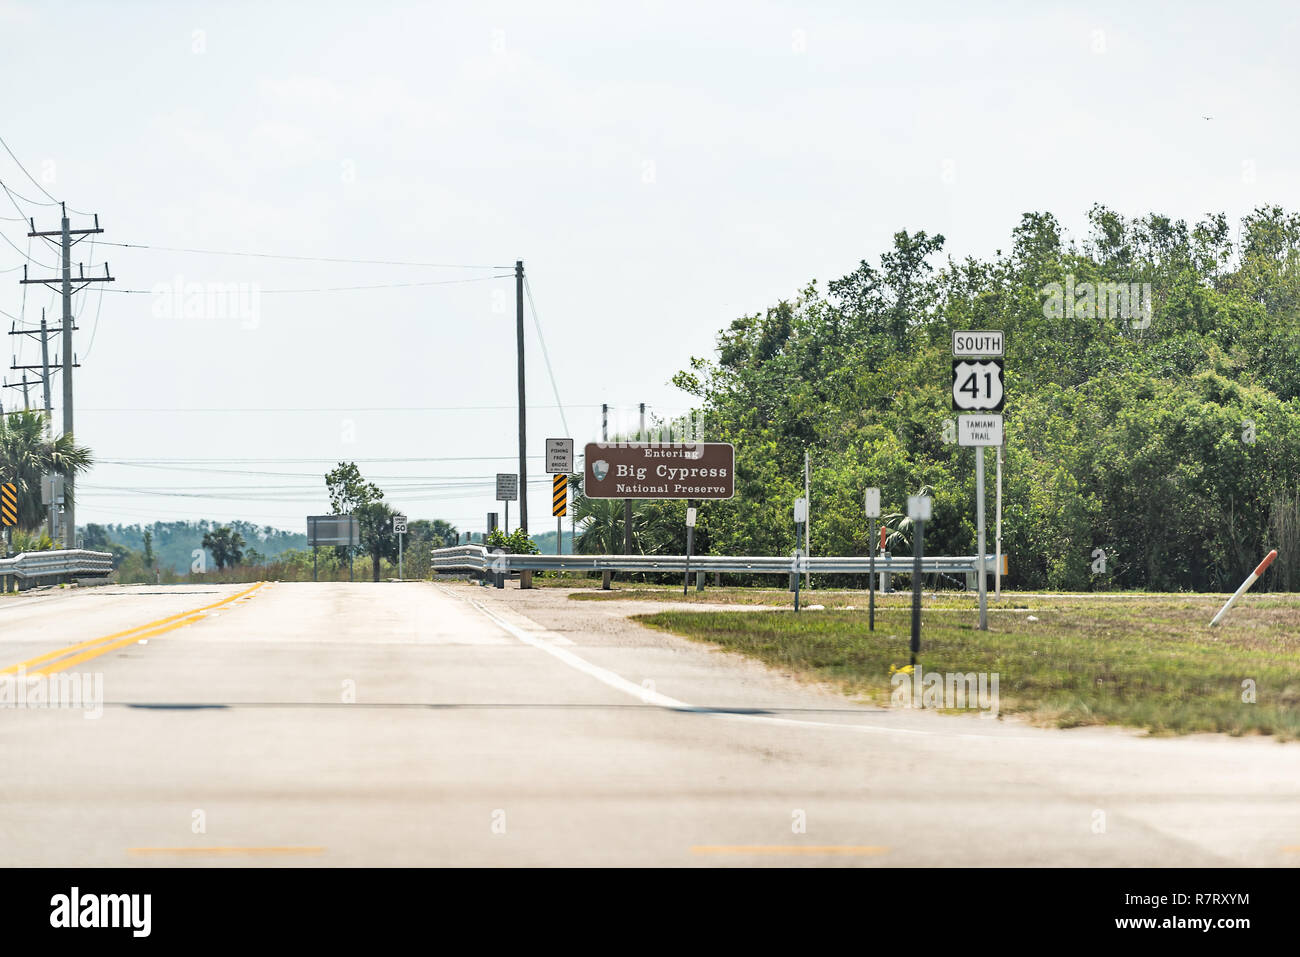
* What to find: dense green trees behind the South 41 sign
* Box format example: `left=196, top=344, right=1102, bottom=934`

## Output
left=650, top=207, right=1300, bottom=590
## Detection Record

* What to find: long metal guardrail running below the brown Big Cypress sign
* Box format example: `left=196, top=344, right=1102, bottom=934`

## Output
left=433, top=545, right=995, bottom=575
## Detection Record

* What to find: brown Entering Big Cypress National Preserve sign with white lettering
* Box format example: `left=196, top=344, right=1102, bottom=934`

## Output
left=582, top=442, right=736, bottom=498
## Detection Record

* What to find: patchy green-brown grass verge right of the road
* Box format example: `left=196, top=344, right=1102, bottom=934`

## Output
left=634, top=589, right=1300, bottom=740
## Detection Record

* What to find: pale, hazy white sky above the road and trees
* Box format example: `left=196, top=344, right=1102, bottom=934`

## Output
left=0, top=0, right=1300, bottom=534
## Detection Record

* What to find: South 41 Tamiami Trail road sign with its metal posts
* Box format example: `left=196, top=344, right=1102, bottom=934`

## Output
left=952, top=332, right=1006, bottom=632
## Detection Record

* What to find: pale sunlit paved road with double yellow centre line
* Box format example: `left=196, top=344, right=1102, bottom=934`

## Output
left=0, top=583, right=1300, bottom=866
